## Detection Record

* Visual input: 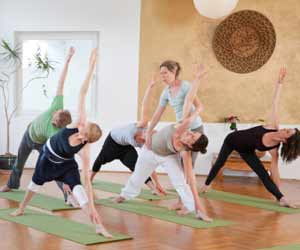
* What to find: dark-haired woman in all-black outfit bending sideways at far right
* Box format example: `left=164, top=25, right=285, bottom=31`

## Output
left=201, top=68, right=300, bottom=207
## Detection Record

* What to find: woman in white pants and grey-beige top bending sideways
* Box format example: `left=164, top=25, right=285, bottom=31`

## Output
left=115, top=65, right=211, bottom=221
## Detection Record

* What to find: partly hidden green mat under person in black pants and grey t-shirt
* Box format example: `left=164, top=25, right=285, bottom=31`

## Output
left=93, top=181, right=177, bottom=200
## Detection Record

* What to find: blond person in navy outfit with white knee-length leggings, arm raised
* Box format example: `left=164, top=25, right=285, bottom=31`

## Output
left=12, top=49, right=112, bottom=237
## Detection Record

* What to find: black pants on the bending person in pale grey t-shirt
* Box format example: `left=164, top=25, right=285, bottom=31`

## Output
left=93, top=134, right=151, bottom=183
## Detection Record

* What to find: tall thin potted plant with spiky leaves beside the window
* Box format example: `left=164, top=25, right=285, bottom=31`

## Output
left=0, top=40, right=54, bottom=170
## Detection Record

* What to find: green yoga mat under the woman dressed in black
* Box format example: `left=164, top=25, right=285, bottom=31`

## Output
left=168, top=189, right=300, bottom=214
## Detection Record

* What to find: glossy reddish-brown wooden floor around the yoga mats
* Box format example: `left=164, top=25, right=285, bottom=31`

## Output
left=0, top=170, right=300, bottom=250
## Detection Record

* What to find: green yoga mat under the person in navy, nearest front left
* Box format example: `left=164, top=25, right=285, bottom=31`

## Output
left=0, top=208, right=131, bottom=245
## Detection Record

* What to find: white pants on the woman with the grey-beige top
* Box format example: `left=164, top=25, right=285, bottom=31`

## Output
left=121, top=146, right=195, bottom=212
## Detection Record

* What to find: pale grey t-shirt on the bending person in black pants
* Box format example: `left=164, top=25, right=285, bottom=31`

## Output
left=110, top=123, right=143, bottom=148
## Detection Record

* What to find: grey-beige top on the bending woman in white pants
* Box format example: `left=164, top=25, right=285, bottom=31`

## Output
left=152, top=124, right=177, bottom=156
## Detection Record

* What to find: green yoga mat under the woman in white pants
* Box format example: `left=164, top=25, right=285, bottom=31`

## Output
left=95, top=198, right=233, bottom=228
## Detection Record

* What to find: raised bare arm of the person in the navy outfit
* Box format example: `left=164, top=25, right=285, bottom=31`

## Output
left=77, top=49, right=97, bottom=126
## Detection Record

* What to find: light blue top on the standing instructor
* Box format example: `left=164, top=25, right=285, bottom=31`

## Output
left=159, top=80, right=202, bottom=129
